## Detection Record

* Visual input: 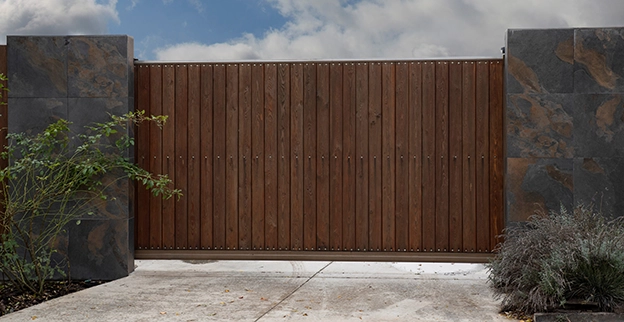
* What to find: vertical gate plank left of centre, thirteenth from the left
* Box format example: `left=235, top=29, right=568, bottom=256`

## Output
left=290, top=63, right=304, bottom=250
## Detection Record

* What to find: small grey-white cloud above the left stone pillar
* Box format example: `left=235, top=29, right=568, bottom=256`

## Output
left=0, top=0, right=119, bottom=43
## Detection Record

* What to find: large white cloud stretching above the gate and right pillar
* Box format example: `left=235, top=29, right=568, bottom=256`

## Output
left=155, top=0, right=624, bottom=60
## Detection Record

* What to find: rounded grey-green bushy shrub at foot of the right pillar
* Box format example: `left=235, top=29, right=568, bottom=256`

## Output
left=488, top=206, right=624, bottom=314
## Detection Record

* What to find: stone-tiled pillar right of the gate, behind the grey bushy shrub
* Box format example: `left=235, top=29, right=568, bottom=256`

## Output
left=505, top=28, right=624, bottom=222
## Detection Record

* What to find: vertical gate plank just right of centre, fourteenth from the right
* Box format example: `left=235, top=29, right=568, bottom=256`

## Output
left=316, top=63, right=331, bottom=250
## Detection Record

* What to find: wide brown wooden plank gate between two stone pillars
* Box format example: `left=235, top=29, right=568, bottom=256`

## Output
left=135, top=59, right=504, bottom=261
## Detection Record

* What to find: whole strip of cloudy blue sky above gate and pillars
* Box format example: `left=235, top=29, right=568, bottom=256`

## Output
left=0, top=0, right=624, bottom=61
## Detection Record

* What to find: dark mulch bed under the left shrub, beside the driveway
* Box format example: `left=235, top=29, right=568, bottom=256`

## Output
left=0, top=280, right=104, bottom=316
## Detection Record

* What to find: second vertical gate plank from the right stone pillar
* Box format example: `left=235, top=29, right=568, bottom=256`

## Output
left=475, top=61, right=490, bottom=252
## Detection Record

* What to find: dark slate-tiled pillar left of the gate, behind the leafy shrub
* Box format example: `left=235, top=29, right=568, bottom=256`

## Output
left=7, top=36, right=134, bottom=280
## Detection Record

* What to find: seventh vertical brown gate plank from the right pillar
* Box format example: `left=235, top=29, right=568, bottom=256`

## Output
left=408, top=62, right=423, bottom=251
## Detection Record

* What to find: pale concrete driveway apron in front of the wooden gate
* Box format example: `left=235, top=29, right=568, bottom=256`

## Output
left=0, top=260, right=509, bottom=321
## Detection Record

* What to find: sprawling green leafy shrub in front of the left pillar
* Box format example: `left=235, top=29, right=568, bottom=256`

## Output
left=0, top=112, right=180, bottom=294
